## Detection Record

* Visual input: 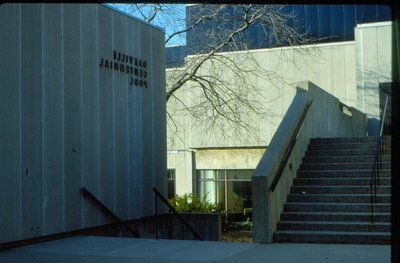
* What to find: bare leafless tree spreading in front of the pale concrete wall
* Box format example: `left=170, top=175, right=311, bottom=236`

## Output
left=111, top=4, right=312, bottom=147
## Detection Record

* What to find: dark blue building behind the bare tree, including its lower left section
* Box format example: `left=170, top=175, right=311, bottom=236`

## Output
left=166, top=4, right=392, bottom=67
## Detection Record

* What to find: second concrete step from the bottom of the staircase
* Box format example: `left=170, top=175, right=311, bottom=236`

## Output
left=277, top=221, right=390, bottom=232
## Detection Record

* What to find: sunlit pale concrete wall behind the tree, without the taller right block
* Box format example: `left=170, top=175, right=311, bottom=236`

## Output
left=167, top=42, right=357, bottom=198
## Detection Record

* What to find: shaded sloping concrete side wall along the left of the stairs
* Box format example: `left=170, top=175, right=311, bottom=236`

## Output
left=252, top=82, right=367, bottom=243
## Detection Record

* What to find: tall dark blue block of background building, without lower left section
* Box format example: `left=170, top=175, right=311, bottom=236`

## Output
left=186, top=4, right=391, bottom=54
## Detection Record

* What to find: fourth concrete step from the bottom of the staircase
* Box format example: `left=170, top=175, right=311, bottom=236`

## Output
left=284, top=202, right=390, bottom=213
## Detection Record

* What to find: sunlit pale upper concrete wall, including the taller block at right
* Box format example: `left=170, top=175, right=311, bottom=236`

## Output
left=167, top=23, right=391, bottom=200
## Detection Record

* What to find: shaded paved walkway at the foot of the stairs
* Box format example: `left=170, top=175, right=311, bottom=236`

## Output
left=0, top=237, right=390, bottom=263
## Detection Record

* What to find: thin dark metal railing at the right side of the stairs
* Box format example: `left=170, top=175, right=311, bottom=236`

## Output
left=369, top=96, right=389, bottom=224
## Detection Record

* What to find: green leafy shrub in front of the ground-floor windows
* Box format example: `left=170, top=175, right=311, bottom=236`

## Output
left=168, top=194, right=219, bottom=213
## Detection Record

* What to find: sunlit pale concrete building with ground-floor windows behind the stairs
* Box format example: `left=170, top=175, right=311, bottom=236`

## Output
left=167, top=22, right=392, bottom=212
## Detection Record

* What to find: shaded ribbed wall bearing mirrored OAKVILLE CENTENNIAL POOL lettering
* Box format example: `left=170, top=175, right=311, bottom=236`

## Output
left=0, top=4, right=166, bottom=242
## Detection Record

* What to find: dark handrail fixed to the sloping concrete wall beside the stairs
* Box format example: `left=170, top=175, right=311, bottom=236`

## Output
left=269, top=100, right=312, bottom=192
